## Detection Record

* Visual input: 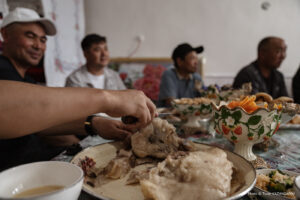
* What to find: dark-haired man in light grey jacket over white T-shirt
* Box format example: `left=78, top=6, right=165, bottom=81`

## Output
left=66, top=34, right=126, bottom=90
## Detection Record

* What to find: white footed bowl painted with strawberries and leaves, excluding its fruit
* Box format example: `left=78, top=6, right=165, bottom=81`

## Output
left=212, top=104, right=282, bottom=161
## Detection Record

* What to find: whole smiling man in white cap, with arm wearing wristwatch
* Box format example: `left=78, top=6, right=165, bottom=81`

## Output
left=0, top=8, right=139, bottom=170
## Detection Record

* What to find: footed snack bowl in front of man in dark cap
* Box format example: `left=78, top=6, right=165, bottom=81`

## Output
left=172, top=98, right=212, bottom=127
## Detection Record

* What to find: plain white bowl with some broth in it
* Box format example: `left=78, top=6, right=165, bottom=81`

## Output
left=0, top=161, right=84, bottom=200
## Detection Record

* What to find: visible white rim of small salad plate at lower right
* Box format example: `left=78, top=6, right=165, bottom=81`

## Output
left=253, top=169, right=300, bottom=200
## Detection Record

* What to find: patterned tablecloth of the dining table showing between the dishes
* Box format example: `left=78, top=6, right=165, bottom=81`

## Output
left=53, top=126, right=300, bottom=200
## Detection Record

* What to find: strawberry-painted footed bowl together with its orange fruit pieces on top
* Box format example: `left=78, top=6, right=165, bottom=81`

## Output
left=212, top=96, right=299, bottom=161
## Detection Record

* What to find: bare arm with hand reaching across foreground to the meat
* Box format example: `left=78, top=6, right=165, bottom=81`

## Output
left=0, top=80, right=156, bottom=139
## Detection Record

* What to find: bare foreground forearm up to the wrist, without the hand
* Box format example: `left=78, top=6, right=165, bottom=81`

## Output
left=0, top=81, right=107, bottom=138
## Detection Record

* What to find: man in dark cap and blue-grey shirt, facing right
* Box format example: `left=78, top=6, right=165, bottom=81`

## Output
left=158, top=43, right=204, bottom=107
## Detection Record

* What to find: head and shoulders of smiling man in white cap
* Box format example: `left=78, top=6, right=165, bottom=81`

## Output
left=0, top=8, right=56, bottom=83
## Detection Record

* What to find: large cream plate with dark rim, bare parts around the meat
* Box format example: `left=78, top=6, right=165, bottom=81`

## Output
left=71, top=142, right=256, bottom=200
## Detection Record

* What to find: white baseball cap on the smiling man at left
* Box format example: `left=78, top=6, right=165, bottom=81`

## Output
left=1, top=7, right=56, bottom=35
